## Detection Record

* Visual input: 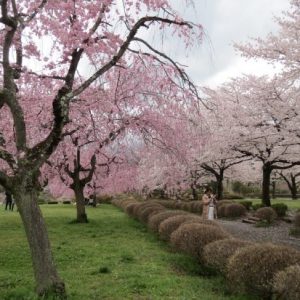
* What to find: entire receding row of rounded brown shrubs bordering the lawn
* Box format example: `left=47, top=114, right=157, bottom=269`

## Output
left=112, top=198, right=300, bottom=300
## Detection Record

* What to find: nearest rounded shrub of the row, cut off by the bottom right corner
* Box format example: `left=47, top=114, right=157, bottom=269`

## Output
left=273, top=265, right=300, bottom=300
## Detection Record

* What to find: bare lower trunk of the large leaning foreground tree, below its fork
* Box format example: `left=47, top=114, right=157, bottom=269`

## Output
left=14, top=188, right=66, bottom=299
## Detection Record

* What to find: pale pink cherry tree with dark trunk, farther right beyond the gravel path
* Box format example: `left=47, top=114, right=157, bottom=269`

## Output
left=211, top=76, right=300, bottom=206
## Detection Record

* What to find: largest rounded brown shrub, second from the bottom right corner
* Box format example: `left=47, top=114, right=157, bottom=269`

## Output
left=227, top=243, right=300, bottom=299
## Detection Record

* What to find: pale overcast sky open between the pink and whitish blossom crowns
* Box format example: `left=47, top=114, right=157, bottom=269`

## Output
left=168, top=0, right=289, bottom=86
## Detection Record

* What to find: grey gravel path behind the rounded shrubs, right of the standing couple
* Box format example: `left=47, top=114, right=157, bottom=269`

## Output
left=216, top=219, right=300, bottom=250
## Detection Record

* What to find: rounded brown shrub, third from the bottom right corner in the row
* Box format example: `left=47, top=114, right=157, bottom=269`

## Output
left=203, top=238, right=253, bottom=274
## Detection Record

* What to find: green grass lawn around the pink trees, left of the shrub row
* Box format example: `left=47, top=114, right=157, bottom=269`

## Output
left=0, top=205, right=255, bottom=300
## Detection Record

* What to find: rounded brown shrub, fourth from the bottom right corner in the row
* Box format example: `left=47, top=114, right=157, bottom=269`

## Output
left=170, top=223, right=229, bottom=261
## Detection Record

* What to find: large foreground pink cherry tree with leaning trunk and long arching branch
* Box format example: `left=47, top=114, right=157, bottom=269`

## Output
left=0, top=0, right=202, bottom=296
